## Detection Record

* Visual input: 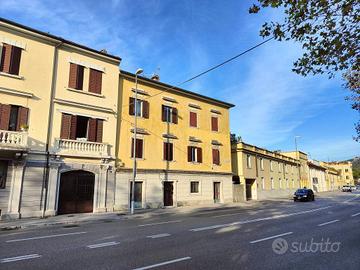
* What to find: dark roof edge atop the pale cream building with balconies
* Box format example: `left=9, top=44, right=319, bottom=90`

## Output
left=0, top=17, right=121, bottom=61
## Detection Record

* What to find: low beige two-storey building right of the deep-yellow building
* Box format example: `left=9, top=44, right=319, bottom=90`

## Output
left=231, top=142, right=301, bottom=201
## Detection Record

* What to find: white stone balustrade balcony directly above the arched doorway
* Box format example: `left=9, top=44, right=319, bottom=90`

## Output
left=56, top=139, right=110, bottom=158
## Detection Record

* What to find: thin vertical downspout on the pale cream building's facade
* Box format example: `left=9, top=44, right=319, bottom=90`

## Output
left=42, top=42, right=63, bottom=218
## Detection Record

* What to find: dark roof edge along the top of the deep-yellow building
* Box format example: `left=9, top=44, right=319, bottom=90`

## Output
left=120, top=70, right=235, bottom=108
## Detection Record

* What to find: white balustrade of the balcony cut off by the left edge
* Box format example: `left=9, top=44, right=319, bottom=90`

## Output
left=0, top=130, right=28, bottom=149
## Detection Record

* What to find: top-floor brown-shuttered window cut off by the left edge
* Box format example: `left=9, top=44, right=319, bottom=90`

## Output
left=0, top=43, right=21, bottom=75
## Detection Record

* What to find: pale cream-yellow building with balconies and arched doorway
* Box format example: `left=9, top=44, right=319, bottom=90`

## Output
left=0, top=19, right=120, bottom=218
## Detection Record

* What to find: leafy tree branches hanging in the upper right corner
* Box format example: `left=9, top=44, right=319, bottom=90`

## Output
left=249, top=0, right=360, bottom=138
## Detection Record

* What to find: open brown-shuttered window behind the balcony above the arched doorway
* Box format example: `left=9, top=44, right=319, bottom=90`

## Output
left=60, top=113, right=104, bottom=143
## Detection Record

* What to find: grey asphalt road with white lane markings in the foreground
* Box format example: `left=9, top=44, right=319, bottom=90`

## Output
left=0, top=192, right=360, bottom=270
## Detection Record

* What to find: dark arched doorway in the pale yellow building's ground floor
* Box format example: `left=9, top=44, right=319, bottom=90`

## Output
left=57, top=170, right=95, bottom=214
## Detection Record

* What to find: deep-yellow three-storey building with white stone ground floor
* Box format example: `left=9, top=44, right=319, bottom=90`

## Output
left=116, top=71, right=233, bottom=209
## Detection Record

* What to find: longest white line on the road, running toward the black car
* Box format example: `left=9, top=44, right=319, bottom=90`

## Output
left=189, top=206, right=331, bottom=232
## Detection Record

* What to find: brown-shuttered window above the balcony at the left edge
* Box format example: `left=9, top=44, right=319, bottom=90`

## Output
left=0, top=104, right=29, bottom=131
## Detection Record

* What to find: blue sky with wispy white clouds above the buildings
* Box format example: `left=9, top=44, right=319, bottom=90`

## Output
left=0, top=0, right=360, bottom=161
